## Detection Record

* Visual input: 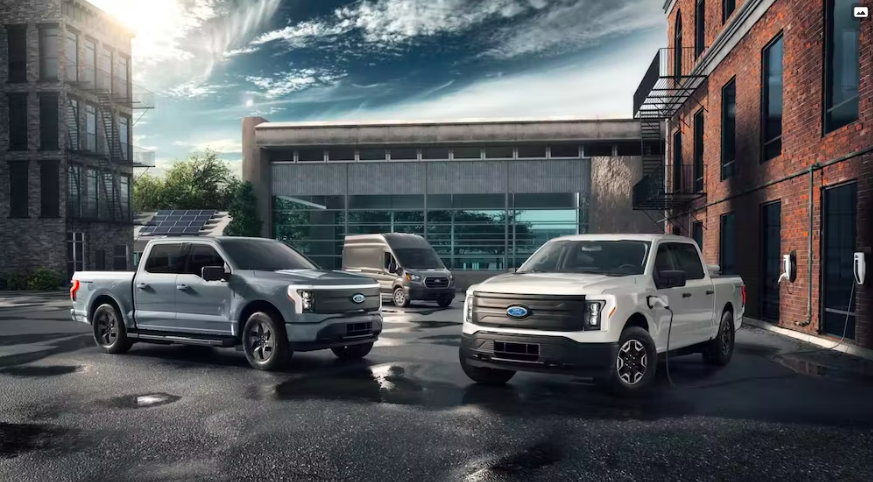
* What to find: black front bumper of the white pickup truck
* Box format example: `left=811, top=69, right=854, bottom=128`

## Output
left=460, top=332, right=618, bottom=377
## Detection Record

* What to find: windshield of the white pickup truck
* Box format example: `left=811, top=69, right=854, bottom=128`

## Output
left=517, top=241, right=650, bottom=276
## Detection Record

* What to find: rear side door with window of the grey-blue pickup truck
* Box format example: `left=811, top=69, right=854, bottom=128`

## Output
left=133, top=243, right=184, bottom=331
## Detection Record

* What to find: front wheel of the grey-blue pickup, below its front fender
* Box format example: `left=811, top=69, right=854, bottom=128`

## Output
left=242, top=311, right=291, bottom=371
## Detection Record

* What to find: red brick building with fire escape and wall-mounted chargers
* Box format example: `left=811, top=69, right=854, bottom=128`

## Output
left=634, top=0, right=873, bottom=348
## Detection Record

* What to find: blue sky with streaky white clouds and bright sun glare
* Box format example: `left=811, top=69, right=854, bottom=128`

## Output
left=90, top=0, right=667, bottom=173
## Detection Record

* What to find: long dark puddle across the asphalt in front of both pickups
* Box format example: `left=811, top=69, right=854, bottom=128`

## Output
left=268, top=364, right=693, bottom=420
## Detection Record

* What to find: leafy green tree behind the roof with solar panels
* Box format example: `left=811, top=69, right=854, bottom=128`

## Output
left=133, top=150, right=240, bottom=211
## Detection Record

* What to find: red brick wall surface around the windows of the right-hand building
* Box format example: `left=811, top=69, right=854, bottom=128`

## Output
left=667, top=0, right=873, bottom=347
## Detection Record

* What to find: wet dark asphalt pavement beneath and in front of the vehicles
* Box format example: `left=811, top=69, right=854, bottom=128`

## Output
left=0, top=306, right=873, bottom=482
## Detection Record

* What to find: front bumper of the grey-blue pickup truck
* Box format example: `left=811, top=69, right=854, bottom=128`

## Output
left=285, top=312, right=382, bottom=351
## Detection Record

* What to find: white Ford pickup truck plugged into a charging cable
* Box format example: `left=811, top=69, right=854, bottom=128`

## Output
left=460, top=234, right=746, bottom=394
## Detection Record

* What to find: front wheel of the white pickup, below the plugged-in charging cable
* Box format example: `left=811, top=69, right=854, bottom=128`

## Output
left=598, top=326, right=658, bottom=395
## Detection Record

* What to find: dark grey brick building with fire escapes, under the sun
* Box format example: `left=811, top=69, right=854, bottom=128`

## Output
left=0, top=0, right=154, bottom=278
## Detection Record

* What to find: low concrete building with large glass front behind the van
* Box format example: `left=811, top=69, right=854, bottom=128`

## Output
left=243, top=118, right=661, bottom=288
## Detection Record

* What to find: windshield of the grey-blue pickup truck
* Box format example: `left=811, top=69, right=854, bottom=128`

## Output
left=221, top=239, right=318, bottom=271
